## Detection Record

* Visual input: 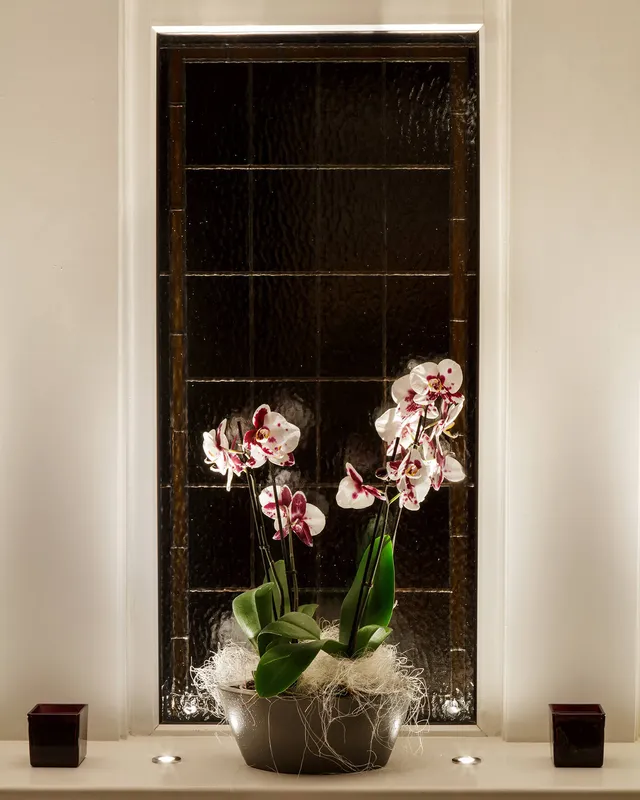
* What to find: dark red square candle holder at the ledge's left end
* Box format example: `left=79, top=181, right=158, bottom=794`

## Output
left=27, top=703, right=89, bottom=767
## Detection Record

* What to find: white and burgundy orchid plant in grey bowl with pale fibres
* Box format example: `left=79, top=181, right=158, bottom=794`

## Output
left=193, top=359, right=464, bottom=773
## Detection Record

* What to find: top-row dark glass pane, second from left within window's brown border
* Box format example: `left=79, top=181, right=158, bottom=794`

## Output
left=253, top=63, right=317, bottom=164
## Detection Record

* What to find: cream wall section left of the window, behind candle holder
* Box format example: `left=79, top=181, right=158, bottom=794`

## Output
left=0, top=0, right=123, bottom=738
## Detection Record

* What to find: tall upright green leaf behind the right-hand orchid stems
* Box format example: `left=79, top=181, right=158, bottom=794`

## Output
left=340, top=536, right=395, bottom=644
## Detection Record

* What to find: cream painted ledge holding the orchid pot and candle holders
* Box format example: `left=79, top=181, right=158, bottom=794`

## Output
left=0, top=734, right=640, bottom=800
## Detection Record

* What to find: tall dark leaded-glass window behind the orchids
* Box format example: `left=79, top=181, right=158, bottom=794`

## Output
left=157, top=34, right=479, bottom=723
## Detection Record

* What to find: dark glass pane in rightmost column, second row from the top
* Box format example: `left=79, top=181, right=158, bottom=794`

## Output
left=387, top=170, right=450, bottom=272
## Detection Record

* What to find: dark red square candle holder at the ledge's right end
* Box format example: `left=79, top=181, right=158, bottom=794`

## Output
left=549, top=704, right=605, bottom=767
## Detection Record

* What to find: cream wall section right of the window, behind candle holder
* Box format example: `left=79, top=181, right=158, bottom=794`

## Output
left=505, top=0, right=640, bottom=739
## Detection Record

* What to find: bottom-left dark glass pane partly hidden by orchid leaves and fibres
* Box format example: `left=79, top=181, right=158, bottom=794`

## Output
left=189, top=592, right=245, bottom=667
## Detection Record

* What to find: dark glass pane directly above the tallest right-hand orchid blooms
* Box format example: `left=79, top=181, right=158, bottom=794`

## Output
left=387, top=275, right=449, bottom=376
